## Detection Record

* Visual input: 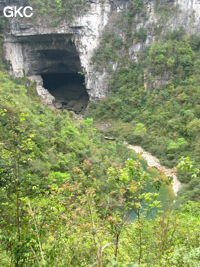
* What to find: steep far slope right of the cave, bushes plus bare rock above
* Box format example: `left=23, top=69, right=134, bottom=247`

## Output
left=87, top=1, right=200, bottom=200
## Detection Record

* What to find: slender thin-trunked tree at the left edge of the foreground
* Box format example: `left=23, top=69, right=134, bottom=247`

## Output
left=0, top=106, right=35, bottom=267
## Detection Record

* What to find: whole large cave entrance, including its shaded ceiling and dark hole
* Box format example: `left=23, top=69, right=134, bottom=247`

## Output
left=17, top=34, right=89, bottom=113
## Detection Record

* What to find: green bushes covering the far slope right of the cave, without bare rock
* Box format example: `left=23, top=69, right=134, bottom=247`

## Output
left=89, top=25, right=200, bottom=200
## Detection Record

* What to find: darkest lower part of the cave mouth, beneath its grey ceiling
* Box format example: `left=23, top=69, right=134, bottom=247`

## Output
left=41, top=73, right=89, bottom=113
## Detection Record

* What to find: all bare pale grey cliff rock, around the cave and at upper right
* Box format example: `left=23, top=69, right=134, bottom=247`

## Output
left=0, top=0, right=200, bottom=108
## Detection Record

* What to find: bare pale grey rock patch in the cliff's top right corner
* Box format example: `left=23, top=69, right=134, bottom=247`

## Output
left=126, top=0, right=200, bottom=59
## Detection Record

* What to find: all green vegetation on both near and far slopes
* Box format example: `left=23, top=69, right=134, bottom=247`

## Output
left=0, top=0, right=200, bottom=267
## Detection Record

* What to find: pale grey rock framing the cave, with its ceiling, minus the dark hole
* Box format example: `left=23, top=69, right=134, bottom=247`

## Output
left=4, top=1, right=117, bottom=107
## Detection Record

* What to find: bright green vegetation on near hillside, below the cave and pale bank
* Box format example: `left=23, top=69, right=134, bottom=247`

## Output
left=0, top=69, right=200, bottom=266
